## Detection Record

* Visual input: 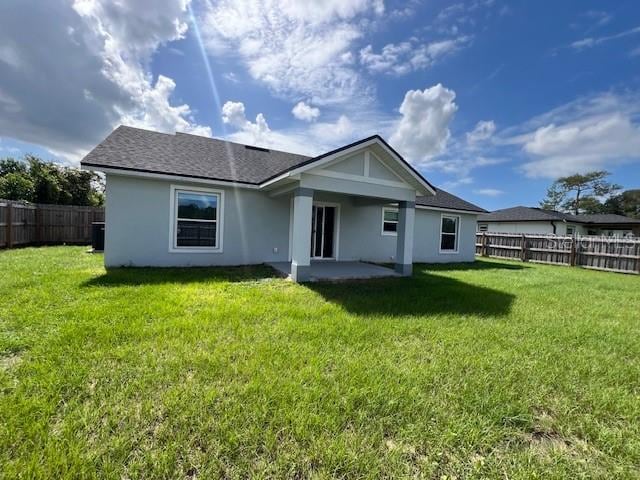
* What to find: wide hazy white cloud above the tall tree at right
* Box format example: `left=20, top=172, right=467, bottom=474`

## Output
left=502, top=93, right=640, bottom=178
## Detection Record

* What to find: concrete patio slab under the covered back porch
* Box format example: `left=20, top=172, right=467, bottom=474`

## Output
left=267, top=261, right=402, bottom=282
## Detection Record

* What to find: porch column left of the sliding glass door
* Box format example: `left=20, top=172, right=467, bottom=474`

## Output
left=290, top=188, right=313, bottom=282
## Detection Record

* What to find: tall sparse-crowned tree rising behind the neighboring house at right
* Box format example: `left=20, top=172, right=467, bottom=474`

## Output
left=540, top=170, right=622, bottom=215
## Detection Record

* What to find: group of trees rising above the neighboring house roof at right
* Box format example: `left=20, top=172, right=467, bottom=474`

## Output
left=540, top=170, right=640, bottom=218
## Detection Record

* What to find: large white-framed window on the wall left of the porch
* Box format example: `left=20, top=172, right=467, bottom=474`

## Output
left=170, top=187, right=222, bottom=252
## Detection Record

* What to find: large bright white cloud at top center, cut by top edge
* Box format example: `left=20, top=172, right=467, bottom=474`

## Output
left=200, top=0, right=384, bottom=105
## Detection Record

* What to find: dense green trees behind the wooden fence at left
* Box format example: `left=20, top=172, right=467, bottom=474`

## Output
left=0, top=155, right=104, bottom=206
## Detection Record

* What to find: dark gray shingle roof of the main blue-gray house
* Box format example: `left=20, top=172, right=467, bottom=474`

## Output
left=81, top=125, right=486, bottom=212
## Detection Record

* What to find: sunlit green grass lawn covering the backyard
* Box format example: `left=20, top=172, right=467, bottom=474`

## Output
left=0, top=247, right=640, bottom=479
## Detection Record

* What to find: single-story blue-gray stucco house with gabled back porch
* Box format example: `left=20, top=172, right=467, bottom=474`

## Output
left=82, top=126, right=484, bottom=281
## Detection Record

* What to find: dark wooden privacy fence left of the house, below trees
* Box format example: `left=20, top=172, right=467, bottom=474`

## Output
left=0, top=200, right=104, bottom=248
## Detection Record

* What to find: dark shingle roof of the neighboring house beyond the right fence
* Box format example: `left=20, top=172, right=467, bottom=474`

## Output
left=478, top=206, right=640, bottom=225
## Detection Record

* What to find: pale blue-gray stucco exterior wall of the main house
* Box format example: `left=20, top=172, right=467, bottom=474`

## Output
left=105, top=175, right=477, bottom=267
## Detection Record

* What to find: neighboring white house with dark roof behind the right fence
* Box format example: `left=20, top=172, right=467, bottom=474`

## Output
left=478, top=207, right=640, bottom=237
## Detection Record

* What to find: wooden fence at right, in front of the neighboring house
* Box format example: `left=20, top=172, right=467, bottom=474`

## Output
left=476, top=232, right=640, bottom=274
